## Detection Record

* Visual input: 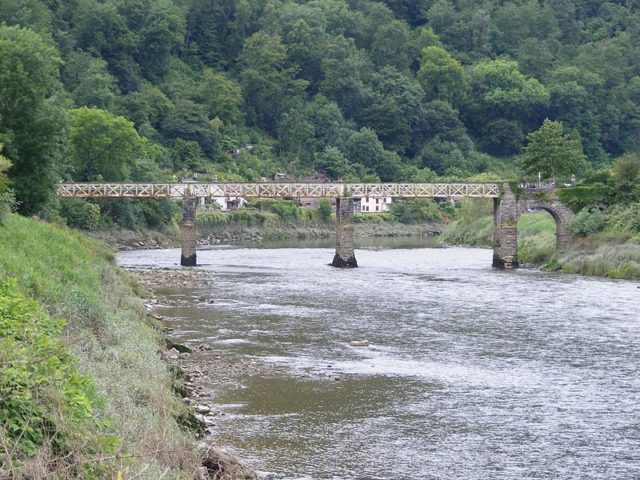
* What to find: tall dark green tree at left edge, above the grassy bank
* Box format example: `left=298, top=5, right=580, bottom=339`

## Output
left=0, top=25, right=66, bottom=214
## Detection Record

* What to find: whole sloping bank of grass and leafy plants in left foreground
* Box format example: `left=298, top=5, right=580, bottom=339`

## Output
left=0, top=215, right=200, bottom=479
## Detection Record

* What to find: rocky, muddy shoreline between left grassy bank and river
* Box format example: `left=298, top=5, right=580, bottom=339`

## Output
left=127, top=268, right=264, bottom=480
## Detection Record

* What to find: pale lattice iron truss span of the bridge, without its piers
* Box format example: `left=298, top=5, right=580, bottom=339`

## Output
left=57, top=182, right=501, bottom=199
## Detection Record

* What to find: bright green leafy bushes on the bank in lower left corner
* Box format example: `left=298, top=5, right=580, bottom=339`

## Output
left=0, top=281, right=117, bottom=472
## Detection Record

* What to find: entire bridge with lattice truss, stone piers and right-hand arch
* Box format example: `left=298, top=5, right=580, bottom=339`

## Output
left=57, top=181, right=571, bottom=268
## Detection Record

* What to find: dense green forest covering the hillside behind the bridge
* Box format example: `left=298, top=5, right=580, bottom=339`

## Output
left=0, top=0, right=640, bottom=227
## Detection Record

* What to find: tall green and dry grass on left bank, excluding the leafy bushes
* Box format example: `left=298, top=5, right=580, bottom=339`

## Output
left=0, top=215, right=198, bottom=479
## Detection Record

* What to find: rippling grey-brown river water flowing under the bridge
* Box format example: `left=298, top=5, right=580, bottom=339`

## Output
left=119, top=243, right=640, bottom=479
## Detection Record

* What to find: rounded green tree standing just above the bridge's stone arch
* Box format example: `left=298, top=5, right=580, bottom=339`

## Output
left=521, top=119, right=586, bottom=180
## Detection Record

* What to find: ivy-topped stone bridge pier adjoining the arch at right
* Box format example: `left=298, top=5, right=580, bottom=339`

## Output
left=493, top=183, right=519, bottom=269
